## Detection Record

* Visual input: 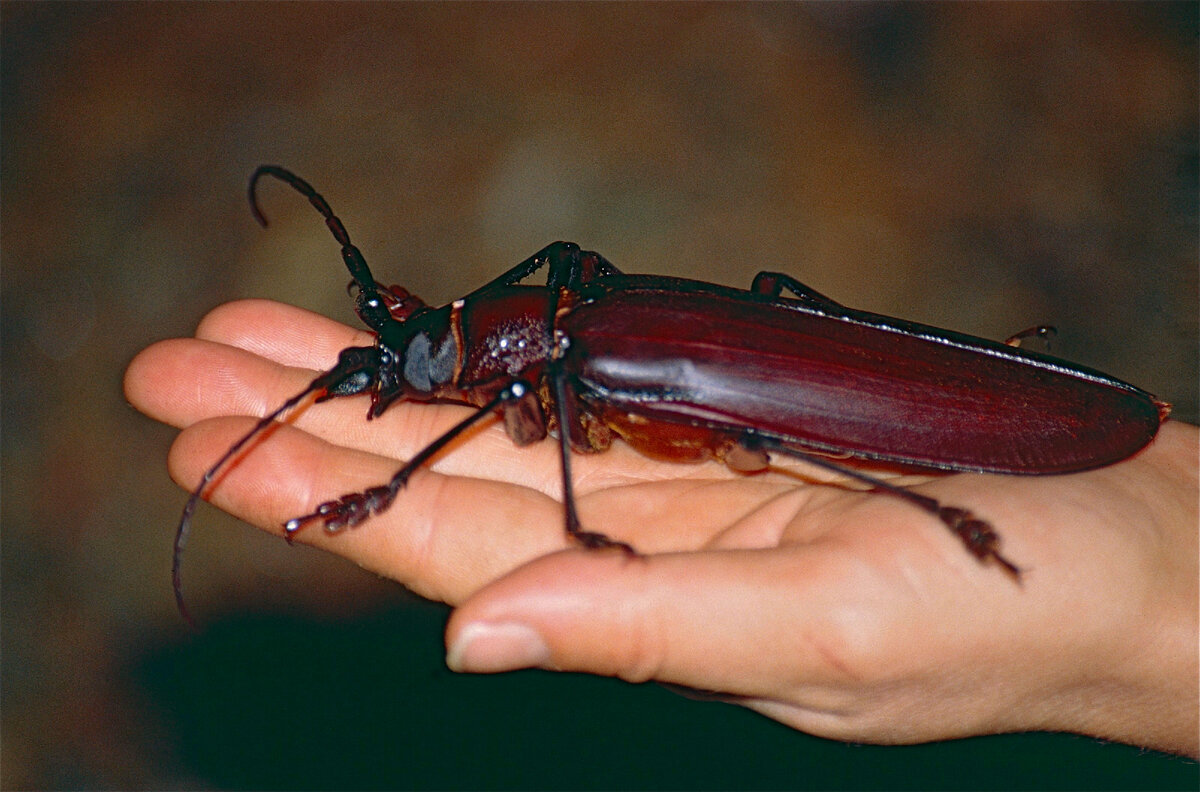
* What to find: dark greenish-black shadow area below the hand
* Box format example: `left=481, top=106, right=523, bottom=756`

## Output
left=127, top=602, right=1200, bottom=790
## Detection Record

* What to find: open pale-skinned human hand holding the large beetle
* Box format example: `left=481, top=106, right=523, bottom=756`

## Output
left=125, top=301, right=1200, bottom=757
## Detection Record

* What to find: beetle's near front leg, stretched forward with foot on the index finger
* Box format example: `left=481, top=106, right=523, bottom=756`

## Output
left=283, top=379, right=533, bottom=542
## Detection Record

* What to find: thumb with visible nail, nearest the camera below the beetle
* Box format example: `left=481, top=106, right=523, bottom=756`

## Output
left=446, top=550, right=844, bottom=695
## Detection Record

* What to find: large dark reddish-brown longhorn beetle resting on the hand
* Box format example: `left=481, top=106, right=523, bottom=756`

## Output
left=173, top=166, right=1170, bottom=622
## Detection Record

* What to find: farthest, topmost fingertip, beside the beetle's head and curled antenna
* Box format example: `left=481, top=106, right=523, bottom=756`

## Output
left=196, top=300, right=376, bottom=371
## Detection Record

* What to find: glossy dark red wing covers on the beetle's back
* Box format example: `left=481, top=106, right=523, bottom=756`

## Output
left=559, top=276, right=1169, bottom=474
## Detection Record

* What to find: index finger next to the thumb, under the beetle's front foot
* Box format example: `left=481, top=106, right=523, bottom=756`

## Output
left=168, top=419, right=566, bottom=602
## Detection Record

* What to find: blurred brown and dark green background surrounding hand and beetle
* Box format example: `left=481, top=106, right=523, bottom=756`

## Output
left=0, top=2, right=1198, bottom=790
